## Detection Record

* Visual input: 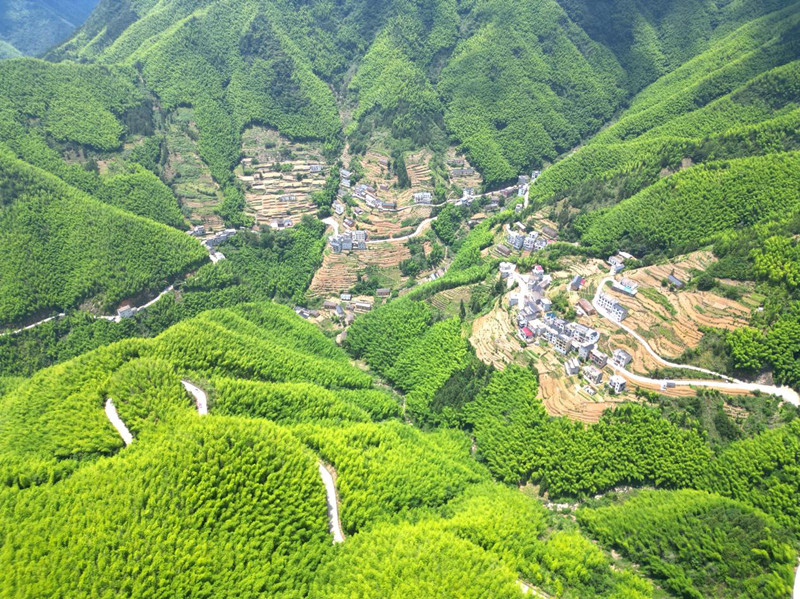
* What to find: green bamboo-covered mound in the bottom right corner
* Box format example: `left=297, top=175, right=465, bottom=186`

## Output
left=578, top=490, right=795, bottom=599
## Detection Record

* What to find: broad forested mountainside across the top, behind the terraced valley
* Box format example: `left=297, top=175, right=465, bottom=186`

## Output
left=39, top=0, right=779, bottom=190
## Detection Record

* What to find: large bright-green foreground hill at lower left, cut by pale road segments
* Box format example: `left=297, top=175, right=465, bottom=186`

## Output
left=0, top=304, right=664, bottom=597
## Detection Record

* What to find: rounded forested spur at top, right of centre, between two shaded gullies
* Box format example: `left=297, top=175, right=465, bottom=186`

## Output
left=439, top=0, right=624, bottom=185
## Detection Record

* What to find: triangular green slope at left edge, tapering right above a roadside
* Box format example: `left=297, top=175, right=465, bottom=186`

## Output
left=0, top=150, right=208, bottom=324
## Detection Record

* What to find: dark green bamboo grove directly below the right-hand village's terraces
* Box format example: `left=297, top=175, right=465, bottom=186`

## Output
left=466, top=367, right=711, bottom=496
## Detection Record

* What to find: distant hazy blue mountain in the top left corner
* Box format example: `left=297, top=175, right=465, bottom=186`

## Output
left=0, top=0, right=97, bottom=58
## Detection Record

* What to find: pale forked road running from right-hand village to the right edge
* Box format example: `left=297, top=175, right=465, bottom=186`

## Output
left=592, top=277, right=800, bottom=406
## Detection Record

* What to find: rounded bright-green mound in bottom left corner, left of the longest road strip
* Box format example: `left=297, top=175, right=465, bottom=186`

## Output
left=0, top=410, right=330, bottom=597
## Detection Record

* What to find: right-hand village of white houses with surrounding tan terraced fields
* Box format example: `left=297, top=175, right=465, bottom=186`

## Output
left=470, top=220, right=781, bottom=422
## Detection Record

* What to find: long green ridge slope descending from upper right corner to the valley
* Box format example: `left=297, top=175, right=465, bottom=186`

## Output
left=531, top=3, right=800, bottom=246
